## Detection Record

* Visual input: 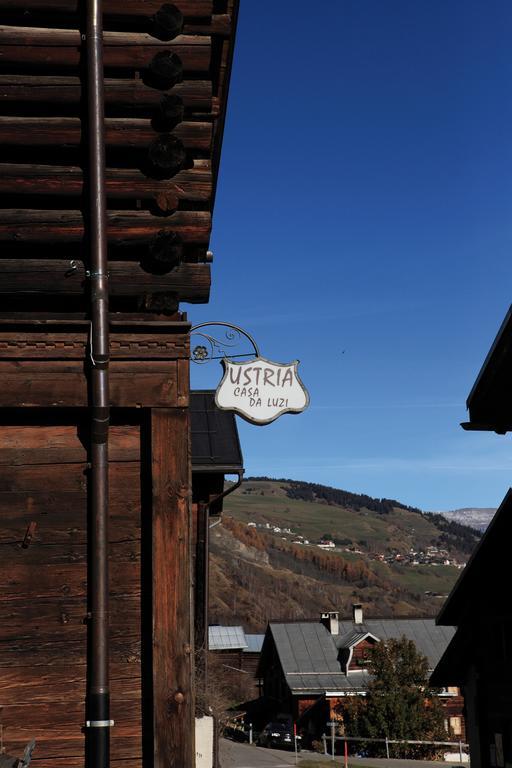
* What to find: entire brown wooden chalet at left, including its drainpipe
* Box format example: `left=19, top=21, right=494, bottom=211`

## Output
left=0, top=0, right=241, bottom=768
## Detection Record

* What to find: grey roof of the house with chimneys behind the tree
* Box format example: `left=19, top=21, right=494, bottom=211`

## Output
left=269, top=619, right=454, bottom=694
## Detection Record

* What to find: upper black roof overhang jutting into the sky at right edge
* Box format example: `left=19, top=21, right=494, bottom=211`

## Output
left=462, top=307, right=512, bottom=434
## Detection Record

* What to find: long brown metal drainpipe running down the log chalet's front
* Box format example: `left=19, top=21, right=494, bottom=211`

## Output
left=86, top=0, right=113, bottom=768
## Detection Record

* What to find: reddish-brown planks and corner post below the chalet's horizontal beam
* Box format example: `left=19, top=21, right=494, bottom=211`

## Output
left=0, top=408, right=194, bottom=768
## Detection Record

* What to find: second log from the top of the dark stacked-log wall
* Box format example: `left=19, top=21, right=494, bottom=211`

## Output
left=0, top=26, right=211, bottom=71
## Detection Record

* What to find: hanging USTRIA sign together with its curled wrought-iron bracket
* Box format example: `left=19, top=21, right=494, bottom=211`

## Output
left=191, top=322, right=309, bottom=425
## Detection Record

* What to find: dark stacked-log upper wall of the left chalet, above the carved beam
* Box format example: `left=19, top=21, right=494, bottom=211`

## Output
left=0, top=0, right=238, bottom=314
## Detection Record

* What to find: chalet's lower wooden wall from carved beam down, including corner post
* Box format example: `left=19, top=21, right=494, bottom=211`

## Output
left=0, top=321, right=194, bottom=768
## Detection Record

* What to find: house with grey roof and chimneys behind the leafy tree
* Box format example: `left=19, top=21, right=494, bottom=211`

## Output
left=256, top=605, right=465, bottom=739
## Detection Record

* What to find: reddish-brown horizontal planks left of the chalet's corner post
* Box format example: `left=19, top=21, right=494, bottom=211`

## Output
left=0, top=436, right=142, bottom=768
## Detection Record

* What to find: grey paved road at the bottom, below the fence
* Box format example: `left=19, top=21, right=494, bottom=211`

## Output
left=220, top=739, right=467, bottom=768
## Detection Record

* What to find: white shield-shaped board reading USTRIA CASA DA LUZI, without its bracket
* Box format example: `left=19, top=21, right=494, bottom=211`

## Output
left=215, top=357, right=309, bottom=424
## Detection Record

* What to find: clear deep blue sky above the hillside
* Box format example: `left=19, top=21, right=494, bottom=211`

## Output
left=189, top=0, right=512, bottom=510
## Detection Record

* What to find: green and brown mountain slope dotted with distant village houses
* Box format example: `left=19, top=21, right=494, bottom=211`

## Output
left=210, top=478, right=479, bottom=630
